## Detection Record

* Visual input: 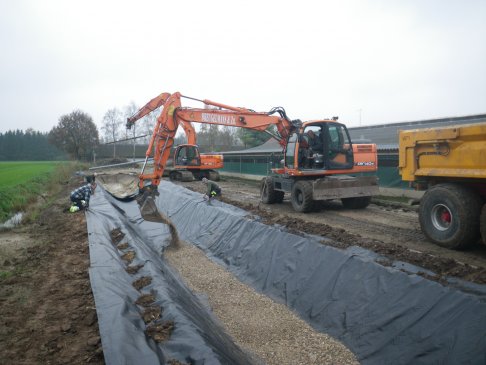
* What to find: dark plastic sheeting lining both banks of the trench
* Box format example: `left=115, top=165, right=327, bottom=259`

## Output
left=87, top=181, right=486, bottom=364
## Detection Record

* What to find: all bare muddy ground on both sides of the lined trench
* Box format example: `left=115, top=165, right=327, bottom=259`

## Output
left=0, top=173, right=486, bottom=364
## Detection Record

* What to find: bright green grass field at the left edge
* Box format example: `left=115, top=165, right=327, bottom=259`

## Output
left=0, top=161, right=70, bottom=222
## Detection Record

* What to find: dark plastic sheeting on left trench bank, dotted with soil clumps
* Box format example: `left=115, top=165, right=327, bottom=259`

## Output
left=86, top=189, right=259, bottom=364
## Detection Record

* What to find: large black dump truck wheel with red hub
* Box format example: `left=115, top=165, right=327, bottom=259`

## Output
left=419, top=184, right=481, bottom=250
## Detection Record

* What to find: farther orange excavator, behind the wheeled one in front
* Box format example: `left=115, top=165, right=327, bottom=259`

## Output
left=127, top=93, right=224, bottom=181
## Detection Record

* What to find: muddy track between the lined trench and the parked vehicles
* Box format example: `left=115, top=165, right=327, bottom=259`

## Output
left=178, top=177, right=486, bottom=284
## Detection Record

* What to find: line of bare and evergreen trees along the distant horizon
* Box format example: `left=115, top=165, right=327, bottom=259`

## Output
left=0, top=102, right=270, bottom=161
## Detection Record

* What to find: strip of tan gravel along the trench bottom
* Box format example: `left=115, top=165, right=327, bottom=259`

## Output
left=164, top=242, right=358, bottom=365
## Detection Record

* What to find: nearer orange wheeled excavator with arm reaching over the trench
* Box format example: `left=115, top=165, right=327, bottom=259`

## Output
left=127, top=92, right=378, bottom=212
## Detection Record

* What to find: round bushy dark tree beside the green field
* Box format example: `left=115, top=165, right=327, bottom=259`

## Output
left=49, top=110, right=99, bottom=160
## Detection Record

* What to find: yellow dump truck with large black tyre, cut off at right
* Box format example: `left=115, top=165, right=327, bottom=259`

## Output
left=399, top=123, right=486, bottom=249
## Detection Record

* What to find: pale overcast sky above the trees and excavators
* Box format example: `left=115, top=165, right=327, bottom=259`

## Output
left=0, top=0, right=486, bottom=132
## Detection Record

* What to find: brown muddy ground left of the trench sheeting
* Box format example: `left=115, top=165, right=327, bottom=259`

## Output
left=0, top=178, right=104, bottom=364
